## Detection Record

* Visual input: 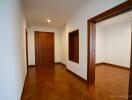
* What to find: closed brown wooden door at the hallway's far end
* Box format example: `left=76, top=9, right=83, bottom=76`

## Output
left=35, top=32, right=54, bottom=65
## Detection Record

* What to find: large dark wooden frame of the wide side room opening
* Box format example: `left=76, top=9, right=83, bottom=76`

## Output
left=87, top=0, right=132, bottom=100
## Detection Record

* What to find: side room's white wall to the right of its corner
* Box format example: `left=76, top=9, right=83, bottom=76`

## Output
left=104, top=21, right=131, bottom=67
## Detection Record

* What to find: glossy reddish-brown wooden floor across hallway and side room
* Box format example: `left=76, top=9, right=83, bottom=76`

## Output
left=21, top=64, right=129, bottom=100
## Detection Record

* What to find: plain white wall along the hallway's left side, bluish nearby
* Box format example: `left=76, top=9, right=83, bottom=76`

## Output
left=0, top=0, right=27, bottom=100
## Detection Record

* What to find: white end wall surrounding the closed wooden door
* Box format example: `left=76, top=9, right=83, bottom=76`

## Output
left=28, top=26, right=61, bottom=65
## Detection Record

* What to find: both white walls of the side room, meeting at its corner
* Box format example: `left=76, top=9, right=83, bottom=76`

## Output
left=96, top=20, right=131, bottom=67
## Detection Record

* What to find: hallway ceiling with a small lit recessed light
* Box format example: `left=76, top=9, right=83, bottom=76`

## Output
left=23, top=0, right=89, bottom=28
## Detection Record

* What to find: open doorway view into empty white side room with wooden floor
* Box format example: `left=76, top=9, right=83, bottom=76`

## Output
left=95, top=11, right=132, bottom=100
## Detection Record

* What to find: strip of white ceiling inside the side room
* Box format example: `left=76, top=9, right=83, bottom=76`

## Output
left=97, top=11, right=132, bottom=27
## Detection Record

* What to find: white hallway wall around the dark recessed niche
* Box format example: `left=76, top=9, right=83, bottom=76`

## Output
left=66, top=0, right=126, bottom=79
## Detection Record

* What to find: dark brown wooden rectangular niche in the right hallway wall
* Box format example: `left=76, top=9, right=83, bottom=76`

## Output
left=68, top=30, right=79, bottom=63
